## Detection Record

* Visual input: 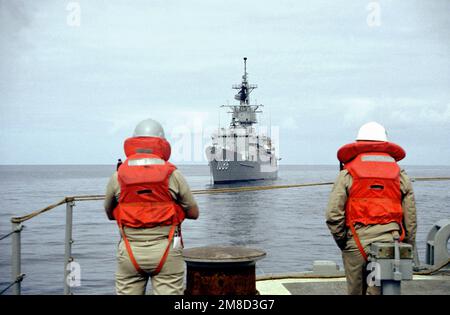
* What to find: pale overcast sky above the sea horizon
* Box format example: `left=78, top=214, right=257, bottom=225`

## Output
left=0, top=0, right=450, bottom=165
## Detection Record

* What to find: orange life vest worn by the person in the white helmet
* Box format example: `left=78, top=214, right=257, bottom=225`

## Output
left=338, top=141, right=405, bottom=260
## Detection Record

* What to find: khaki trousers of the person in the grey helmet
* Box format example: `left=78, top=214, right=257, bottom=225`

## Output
left=116, top=227, right=184, bottom=295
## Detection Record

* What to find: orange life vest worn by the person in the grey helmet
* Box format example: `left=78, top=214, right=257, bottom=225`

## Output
left=113, top=137, right=185, bottom=274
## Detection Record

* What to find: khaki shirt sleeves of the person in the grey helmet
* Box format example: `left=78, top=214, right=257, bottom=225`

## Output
left=104, top=170, right=197, bottom=217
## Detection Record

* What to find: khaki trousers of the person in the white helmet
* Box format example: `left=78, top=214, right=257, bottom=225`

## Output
left=342, top=249, right=381, bottom=295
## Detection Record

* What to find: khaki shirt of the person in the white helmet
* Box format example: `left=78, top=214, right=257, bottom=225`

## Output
left=326, top=170, right=417, bottom=250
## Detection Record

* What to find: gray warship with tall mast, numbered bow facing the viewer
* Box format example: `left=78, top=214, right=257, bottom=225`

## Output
left=206, top=57, right=278, bottom=184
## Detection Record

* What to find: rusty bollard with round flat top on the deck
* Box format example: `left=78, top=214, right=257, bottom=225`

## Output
left=183, top=246, right=266, bottom=295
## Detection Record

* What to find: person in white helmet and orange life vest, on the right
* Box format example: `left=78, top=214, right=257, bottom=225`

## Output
left=326, top=122, right=417, bottom=295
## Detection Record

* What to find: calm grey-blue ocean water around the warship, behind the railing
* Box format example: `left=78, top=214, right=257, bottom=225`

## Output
left=0, top=165, right=450, bottom=294
